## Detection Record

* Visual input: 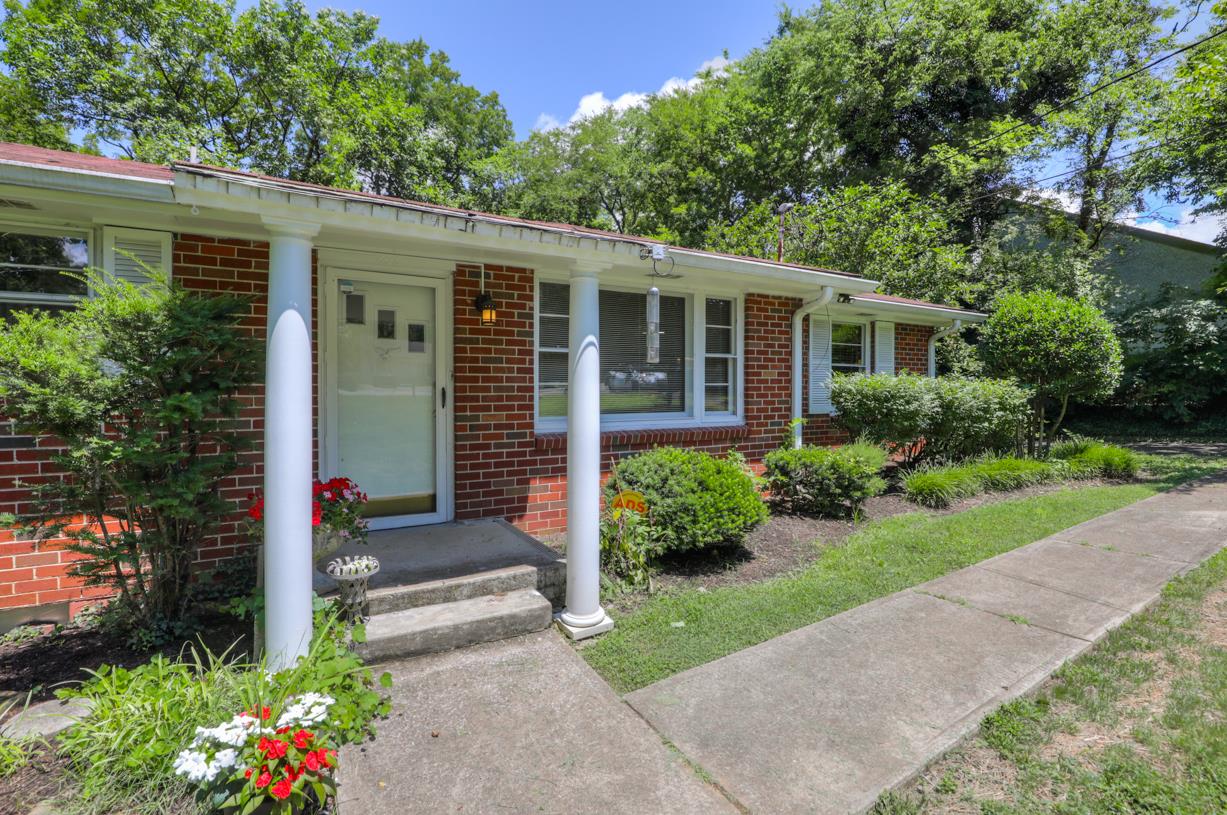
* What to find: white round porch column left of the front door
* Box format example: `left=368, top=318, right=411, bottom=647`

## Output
left=264, top=218, right=319, bottom=670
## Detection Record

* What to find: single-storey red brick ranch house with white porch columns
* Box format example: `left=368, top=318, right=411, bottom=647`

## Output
left=0, top=144, right=983, bottom=651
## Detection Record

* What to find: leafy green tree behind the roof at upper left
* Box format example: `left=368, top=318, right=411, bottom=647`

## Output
left=0, top=0, right=512, bottom=203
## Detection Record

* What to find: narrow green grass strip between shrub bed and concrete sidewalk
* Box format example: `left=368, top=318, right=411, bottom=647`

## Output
left=580, top=457, right=1227, bottom=692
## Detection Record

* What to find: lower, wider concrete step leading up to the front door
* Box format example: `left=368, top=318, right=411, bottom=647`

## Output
left=357, top=588, right=552, bottom=662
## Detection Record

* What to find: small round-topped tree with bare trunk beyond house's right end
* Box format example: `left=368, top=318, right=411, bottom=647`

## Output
left=979, top=291, right=1121, bottom=454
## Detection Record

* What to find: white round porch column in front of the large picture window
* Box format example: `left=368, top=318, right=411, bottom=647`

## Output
left=560, top=264, right=614, bottom=639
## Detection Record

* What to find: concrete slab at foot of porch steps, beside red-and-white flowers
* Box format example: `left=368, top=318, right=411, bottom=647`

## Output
left=337, top=630, right=736, bottom=815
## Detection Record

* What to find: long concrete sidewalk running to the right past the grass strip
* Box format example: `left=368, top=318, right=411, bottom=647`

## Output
left=628, top=475, right=1227, bottom=815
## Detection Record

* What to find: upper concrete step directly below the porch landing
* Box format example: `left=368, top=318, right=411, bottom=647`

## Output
left=367, top=561, right=567, bottom=615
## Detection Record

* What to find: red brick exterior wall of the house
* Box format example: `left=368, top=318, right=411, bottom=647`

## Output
left=0, top=234, right=931, bottom=609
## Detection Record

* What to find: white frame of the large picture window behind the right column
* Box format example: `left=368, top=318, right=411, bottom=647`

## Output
left=533, top=274, right=746, bottom=433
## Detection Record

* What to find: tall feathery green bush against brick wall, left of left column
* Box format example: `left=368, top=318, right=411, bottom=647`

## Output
left=0, top=274, right=263, bottom=639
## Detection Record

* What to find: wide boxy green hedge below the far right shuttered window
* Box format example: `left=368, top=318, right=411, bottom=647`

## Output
left=831, top=372, right=1028, bottom=465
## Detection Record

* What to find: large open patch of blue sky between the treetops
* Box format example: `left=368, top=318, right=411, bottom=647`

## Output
left=307, top=0, right=780, bottom=137
